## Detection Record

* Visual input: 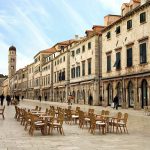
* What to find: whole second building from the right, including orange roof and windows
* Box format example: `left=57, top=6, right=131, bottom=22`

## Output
left=69, top=26, right=103, bottom=105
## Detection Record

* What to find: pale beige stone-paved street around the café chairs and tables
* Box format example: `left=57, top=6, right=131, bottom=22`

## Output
left=0, top=100, right=150, bottom=150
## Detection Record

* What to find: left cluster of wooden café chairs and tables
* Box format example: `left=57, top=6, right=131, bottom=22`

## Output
left=15, top=106, right=64, bottom=135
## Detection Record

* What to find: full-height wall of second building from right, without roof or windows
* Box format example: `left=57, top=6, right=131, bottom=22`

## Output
left=69, top=35, right=101, bottom=105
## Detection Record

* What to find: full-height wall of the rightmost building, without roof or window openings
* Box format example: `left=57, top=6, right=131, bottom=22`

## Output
left=102, top=6, right=150, bottom=109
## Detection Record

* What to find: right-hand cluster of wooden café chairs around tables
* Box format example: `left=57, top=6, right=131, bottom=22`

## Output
left=73, top=109, right=128, bottom=134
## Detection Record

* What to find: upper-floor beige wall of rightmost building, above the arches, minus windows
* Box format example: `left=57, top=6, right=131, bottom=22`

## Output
left=102, top=7, right=150, bottom=78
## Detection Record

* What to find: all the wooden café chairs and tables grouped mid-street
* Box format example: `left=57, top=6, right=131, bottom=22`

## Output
left=15, top=106, right=128, bottom=135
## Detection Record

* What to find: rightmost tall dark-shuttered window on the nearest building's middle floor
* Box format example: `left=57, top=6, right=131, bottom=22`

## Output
left=140, top=43, right=147, bottom=64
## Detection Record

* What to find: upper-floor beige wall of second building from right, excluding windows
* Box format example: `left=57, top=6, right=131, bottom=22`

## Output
left=70, top=36, right=97, bottom=83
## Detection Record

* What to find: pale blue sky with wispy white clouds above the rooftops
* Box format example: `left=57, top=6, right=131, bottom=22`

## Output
left=0, top=0, right=129, bottom=75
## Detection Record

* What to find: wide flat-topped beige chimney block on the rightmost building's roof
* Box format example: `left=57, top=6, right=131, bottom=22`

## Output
left=104, top=15, right=121, bottom=26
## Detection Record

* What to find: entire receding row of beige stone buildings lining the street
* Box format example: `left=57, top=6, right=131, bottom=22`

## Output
left=9, top=0, right=150, bottom=109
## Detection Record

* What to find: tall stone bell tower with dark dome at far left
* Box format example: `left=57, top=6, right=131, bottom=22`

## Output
left=8, top=46, right=16, bottom=79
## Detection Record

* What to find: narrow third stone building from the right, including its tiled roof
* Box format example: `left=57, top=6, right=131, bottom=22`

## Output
left=53, top=39, right=79, bottom=102
